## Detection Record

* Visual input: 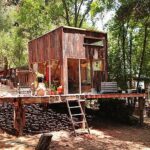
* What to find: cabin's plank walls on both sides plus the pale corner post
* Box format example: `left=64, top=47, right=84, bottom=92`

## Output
left=28, top=27, right=108, bottom=94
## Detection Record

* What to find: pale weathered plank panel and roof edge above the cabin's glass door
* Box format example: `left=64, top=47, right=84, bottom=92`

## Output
left=62, top=28, right=106, bottom=59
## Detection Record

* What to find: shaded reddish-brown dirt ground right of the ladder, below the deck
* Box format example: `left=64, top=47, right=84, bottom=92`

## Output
left=87, top=109, right=150, bottom=147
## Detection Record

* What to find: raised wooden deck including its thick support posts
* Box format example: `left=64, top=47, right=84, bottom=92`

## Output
left=0, top=85, right=146, bottom=135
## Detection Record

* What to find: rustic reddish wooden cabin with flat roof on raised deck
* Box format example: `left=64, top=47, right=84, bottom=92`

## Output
left=28, top=26, right=107, bottom=94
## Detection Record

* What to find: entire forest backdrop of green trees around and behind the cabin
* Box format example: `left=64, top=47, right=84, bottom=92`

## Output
left=0, top=0, right=150, bottom=88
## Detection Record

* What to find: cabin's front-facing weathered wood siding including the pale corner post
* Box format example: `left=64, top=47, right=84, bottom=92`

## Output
left=62, top=27, right=107, bottom=94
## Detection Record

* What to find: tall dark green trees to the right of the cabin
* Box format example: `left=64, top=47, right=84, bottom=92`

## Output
left=108, top=0, right=150, bottom=88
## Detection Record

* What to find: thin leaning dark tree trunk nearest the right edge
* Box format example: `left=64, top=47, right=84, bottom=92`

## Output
left=137, top=25, right=148, bottom=88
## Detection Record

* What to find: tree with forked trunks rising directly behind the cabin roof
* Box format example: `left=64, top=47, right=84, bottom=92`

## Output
left=46, top=0, right=93, bottom=28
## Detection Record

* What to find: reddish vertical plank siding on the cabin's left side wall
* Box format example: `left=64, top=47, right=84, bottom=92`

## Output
left=28, top=29, right=62, bottom=64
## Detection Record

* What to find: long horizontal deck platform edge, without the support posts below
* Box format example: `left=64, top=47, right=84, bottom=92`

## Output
left=0, top=93, right=146, bottom=104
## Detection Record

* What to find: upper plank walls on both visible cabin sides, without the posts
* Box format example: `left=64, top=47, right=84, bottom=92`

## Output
left=28, top=27, right=107, bottom=64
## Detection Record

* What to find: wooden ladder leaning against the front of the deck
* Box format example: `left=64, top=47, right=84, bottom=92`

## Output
left=66, top=99, right=90, bottom=136
